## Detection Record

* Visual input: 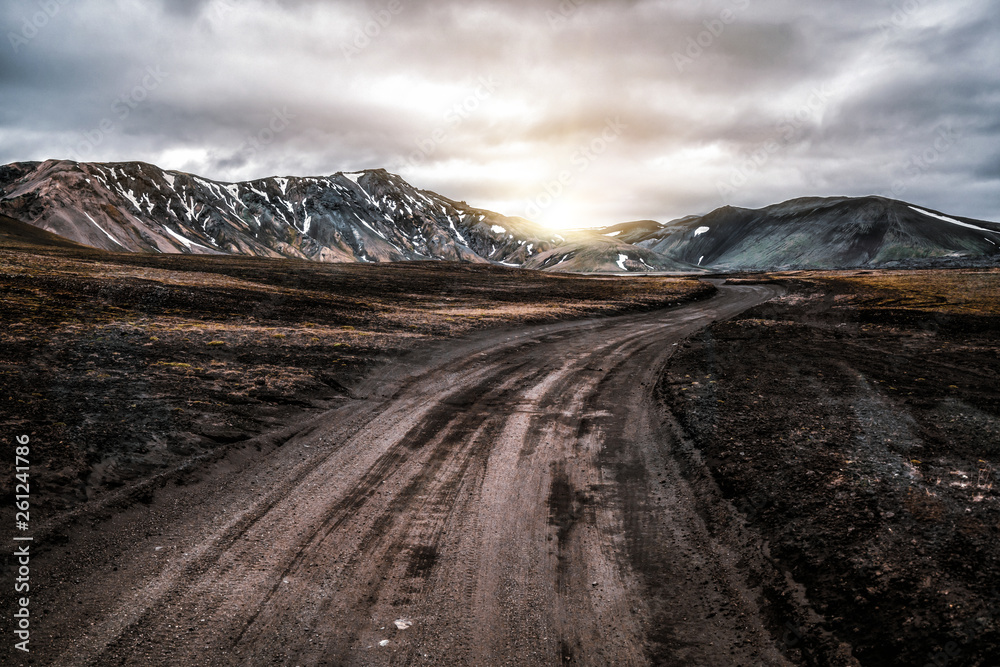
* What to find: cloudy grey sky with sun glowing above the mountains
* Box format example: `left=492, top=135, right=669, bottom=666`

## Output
left=0, top=0, right=1000, bottom=227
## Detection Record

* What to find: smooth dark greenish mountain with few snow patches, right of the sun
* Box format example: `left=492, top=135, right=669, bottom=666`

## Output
left=600, top=197, right=1000, bottom=271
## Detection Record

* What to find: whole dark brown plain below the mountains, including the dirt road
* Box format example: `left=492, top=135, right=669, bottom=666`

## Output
left=0, top=222, right=1000, bottom=667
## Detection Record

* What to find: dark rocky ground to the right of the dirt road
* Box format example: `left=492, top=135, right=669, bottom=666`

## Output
left=659, top=269, right=1000, bottom=667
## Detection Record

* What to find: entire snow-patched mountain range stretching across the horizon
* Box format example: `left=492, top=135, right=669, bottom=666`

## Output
left=0, top=160, right=1000, bottom=273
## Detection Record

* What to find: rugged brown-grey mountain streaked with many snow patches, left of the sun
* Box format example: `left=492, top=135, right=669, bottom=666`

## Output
left=0, top=160, right=580, bottom=266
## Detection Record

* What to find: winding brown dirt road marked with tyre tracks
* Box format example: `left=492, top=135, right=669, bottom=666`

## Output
left=14, top=286, right=786, bottom=667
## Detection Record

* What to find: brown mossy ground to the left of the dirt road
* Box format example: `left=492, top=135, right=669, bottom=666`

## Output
left=0, top=243, right=713, bottom=520
